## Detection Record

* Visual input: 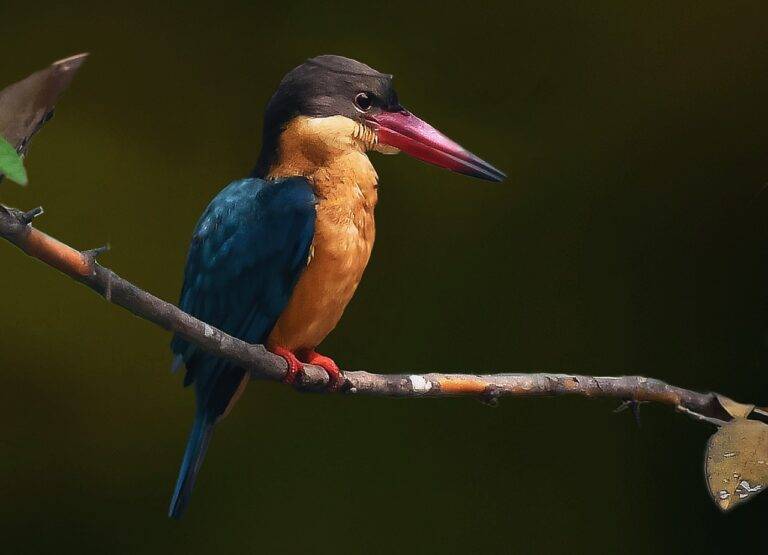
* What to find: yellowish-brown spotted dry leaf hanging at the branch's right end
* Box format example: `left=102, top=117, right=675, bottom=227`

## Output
left=704, top=418, right=768, bottom=511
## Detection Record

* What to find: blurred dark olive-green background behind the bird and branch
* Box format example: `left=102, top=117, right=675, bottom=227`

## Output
left=0, top=0, right=768, bottom=554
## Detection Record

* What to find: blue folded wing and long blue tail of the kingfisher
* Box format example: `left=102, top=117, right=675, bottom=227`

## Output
left=170, top=178, right=316, bottom=517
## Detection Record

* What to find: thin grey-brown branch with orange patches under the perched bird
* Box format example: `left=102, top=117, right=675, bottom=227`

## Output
left=0, top=201, right=730, bottom=420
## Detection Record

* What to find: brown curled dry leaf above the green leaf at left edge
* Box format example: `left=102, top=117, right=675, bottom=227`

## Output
left=0, top=54, right=88, bottom=181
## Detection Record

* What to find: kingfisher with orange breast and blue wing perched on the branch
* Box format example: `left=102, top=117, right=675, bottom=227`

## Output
left=169, top=55, right=505, bottom=518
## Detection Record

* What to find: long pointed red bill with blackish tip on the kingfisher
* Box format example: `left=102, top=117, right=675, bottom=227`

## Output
left=368, top=110, right=506, bottom=181
